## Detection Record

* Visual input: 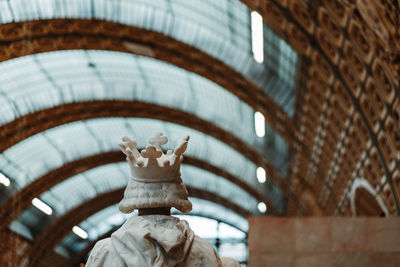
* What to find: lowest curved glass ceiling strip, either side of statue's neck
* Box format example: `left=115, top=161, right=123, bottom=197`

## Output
left=55, top=200, right=248, bottom=257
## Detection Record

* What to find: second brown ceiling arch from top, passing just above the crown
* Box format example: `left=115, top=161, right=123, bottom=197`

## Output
left=1, top=101, right=287, bottom=192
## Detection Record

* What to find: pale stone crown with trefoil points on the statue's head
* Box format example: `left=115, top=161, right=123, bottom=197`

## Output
left=119, top=132, right=189, bottom=183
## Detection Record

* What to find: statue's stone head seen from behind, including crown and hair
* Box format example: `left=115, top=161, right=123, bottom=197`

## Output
left=119, top=132, right=192, bottom=213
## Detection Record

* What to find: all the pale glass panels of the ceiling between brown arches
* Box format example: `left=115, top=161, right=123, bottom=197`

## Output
left=0, top=0, right=298, bottom=251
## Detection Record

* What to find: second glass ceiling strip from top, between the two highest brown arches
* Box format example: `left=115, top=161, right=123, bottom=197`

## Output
left=0, top=50, right=288, bottom=175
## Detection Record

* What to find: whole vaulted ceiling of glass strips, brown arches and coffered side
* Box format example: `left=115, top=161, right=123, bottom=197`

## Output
left=0, top=0, right=400, bottom=266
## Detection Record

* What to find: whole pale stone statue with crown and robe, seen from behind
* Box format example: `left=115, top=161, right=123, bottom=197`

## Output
left=86, top=133, right=240, bottom=267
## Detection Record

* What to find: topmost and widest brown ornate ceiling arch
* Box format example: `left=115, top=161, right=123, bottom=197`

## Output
left=0, top=19, right=296, bottom=149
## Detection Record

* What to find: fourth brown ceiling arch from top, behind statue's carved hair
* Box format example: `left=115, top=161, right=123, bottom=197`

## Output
left=26, top=187, right=249, bottom=266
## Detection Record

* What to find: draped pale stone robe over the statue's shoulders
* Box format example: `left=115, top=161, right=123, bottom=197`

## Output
left=86, top=215, right=240, bottom=267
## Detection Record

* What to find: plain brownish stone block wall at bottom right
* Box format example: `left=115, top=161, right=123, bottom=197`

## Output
left=248, top=217, right=400, bottom=267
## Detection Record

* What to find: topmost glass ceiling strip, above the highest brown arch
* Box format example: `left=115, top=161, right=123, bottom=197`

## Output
left=0, top=0, right=297, bottom=116
